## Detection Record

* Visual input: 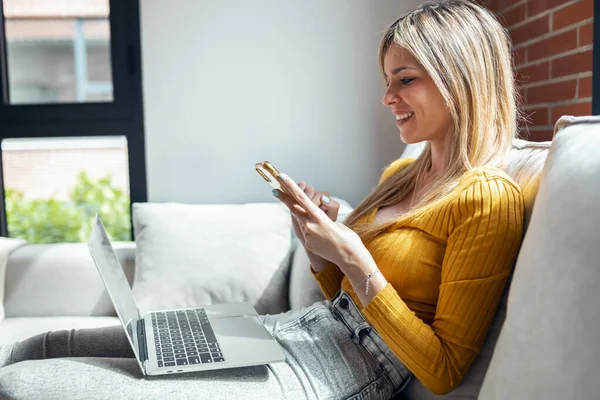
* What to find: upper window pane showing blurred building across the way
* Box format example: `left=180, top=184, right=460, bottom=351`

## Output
left=4, top=0, right=113, bottom=104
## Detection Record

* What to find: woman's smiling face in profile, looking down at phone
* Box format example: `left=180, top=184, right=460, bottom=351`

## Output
left=382, top=45, right=453, bottom=144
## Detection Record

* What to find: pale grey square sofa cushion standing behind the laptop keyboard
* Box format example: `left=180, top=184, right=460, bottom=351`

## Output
left=133, top=203, right=292, bottom=314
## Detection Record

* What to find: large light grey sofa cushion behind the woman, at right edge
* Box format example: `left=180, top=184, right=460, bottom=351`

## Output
left=480, top=117, right=600, bottom=399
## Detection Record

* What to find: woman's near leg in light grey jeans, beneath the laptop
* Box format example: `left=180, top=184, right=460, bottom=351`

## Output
left=0, top=357, right=292, bottom=400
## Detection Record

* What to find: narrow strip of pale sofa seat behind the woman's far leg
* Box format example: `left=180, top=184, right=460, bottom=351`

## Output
left=0, top=317, right=120, bottom=344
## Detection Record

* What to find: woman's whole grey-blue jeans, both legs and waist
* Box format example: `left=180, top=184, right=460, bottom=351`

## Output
left=0, top=291, right=412, bottom=400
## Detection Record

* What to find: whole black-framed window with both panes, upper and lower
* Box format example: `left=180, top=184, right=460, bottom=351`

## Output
left=0, top=0, right=147, bottom=243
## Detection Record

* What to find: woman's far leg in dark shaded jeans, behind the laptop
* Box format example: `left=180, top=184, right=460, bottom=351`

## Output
left=4, top=325, right=134, bottom=365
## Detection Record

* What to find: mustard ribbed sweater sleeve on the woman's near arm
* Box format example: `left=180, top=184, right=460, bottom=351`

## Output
left=363, top=177, right=524, bottom=394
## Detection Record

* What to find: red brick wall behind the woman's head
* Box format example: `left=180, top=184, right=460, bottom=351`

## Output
left=485, top=0, right=594, bottom=141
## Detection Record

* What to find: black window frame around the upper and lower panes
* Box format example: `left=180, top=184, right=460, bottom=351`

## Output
left=0, top=0, right=148, bottom=239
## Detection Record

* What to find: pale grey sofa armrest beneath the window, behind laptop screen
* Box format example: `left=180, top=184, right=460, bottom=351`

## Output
left=4, top=242, right=135, bottom=317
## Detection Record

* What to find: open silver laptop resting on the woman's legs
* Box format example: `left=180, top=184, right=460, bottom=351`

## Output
left=88, top=216, right=285, bottom=375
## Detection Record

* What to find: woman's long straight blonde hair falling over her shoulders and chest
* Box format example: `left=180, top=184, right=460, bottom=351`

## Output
left=345, top=0, right=519, bottom=241
